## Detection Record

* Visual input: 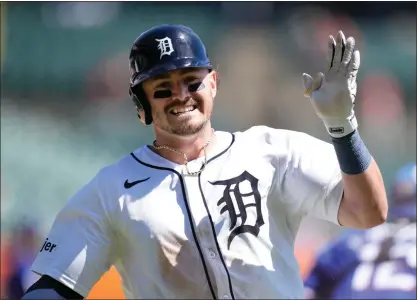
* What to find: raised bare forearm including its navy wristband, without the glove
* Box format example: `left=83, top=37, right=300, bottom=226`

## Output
left=333, top=132, right=388, bottom=228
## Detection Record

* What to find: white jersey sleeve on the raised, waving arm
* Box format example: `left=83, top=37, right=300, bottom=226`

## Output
left=278, top=127, right=343, bottom=225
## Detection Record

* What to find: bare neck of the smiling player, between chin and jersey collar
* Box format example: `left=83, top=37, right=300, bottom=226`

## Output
left=152, top=122, right=215, bottom=164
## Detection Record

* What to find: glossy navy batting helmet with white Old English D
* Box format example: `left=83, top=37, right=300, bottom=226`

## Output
left=129, top=25, right=212, bottom=125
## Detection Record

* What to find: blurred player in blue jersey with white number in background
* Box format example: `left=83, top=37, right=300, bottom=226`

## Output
left=305, top=163, right=417, bottom=299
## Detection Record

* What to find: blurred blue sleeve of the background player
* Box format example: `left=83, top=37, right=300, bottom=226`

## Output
left=305, top=232, right=358, bottom=296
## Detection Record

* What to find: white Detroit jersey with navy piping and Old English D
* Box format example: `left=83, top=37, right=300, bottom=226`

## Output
left=29, top=126, right=343, bottom=299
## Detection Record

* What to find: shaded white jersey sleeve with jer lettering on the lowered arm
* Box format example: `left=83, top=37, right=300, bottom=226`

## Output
left=32, top=169, right=113, bottom=297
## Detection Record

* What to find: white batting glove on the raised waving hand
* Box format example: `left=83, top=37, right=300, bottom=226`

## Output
left=302, top=31, right=360, bottom=138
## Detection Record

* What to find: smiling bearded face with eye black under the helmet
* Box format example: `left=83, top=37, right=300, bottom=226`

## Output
left=143, top=68, right=216, bottom=136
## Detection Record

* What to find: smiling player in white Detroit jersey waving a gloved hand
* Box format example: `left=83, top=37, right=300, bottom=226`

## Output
left=24, top=25, right=387, bottom=299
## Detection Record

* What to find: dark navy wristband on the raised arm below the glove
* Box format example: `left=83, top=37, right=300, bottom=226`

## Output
left=332, top=130, right=372, bottom=175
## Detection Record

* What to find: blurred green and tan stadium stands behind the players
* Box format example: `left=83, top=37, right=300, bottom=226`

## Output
left=1, top=1, right=417, bottom=299
